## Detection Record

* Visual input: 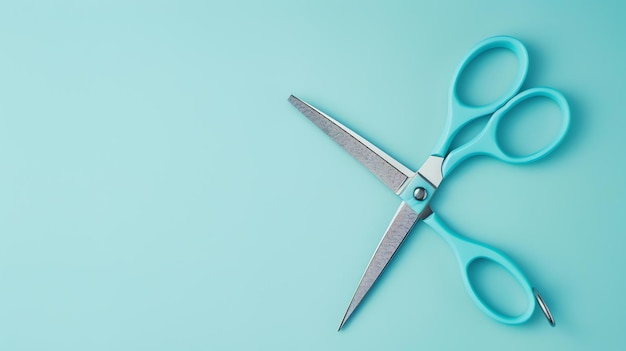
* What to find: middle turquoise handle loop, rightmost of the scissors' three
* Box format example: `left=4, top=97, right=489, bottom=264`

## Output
left=442, top=88, right=570, bottom=177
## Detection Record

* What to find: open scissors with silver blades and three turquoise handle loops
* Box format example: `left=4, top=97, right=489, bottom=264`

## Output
left=288, top=36, right=570, bottom=330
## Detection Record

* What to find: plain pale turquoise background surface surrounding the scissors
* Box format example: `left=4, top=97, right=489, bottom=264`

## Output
left=0, top=0, right=626, bottom=351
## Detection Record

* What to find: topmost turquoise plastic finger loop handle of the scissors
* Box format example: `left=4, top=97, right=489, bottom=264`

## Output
left=433, top=36, right=528, bottom=157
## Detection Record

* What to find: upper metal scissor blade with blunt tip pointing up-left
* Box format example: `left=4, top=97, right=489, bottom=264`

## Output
left=288, top=95, right=415, bottom=194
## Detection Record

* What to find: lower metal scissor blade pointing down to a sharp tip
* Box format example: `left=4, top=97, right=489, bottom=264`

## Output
left=339, top=202, right=420, bottom=330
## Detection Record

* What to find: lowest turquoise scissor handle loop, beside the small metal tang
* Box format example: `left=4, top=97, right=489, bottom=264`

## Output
left=424, top=213, right=536, bottom=324
